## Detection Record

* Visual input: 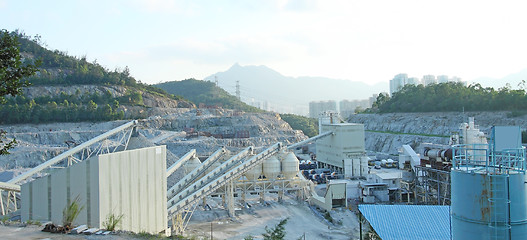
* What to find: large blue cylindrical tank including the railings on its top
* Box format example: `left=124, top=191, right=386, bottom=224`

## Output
left=451, top=144, right=527, bottom=239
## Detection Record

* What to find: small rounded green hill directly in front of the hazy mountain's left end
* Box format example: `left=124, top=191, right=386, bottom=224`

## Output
left=154, top=79, right=263, bottom=112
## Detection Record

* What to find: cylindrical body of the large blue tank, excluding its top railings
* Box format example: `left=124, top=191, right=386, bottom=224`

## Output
left=451, top=170, right=527, bottom=240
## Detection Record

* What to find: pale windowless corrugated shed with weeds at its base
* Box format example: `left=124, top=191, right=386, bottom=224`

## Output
left=21, top=146, right=167, bottom=233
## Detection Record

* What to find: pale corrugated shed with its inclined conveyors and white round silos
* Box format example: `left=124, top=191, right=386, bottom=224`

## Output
left=0, top=117, right=354, bottom=235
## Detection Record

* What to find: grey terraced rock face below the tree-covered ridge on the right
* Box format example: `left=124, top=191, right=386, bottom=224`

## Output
left=348, top=112, right=527, bottom=155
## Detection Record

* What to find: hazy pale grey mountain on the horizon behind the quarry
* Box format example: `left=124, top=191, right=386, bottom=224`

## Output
left=205, top=64, right=388, bottom=115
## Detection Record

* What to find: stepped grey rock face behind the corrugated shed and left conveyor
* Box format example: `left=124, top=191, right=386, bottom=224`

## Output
left=0, top=108, right=307, bottom=170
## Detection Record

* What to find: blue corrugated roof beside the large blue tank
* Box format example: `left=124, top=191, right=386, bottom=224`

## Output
left=359, top=205, right=450, bottom=240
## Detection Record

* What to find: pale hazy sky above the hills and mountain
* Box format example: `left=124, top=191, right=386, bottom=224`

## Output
left=0, top=0, right=527, bottom=83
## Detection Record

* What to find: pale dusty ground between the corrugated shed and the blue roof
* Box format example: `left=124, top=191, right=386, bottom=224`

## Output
left=185, top=196, right=359, bottom=239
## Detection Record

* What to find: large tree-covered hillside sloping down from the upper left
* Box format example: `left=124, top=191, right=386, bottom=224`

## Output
left=0, top=31, right=195, bottom=124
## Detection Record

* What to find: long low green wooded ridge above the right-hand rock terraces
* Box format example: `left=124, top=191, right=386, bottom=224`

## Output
left=371, top=82, right=527, bottom=113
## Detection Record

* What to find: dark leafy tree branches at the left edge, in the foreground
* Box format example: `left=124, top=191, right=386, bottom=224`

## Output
left=0, top=29, right=40, bottom=155
